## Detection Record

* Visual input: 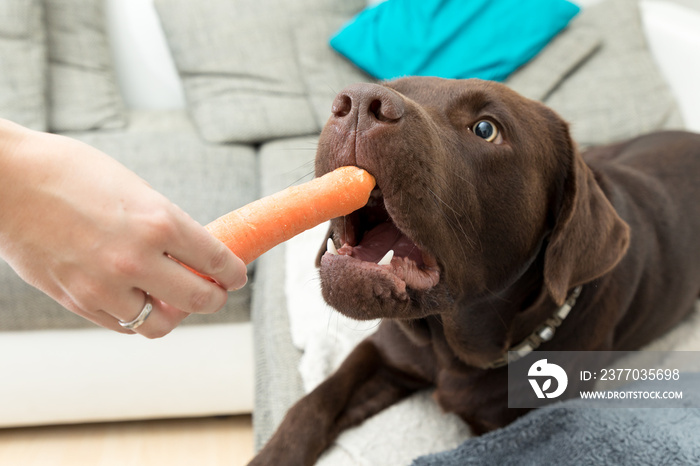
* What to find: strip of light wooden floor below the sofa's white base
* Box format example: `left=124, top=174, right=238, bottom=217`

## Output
left=0, top=416, right=253, bottom=466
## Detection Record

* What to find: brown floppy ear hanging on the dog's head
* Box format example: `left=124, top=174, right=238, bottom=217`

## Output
left=544, top=148, right=630, bottom=306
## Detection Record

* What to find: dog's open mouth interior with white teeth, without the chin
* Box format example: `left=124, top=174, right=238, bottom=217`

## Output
left=322, top=188, right=440, bottom=293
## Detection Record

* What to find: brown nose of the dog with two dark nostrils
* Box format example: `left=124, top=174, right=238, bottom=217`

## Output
left=331, top=84, right=404, bottom=131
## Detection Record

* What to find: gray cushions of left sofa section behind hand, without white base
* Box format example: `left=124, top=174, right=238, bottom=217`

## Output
left=0, top=0, right=258, bottom=332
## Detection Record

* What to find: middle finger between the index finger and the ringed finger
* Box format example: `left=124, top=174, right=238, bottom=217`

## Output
left=139, top=255, right=228, bottom=314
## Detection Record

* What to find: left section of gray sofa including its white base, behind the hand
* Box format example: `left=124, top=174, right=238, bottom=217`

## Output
left=0, top=0, right=259, bottom=427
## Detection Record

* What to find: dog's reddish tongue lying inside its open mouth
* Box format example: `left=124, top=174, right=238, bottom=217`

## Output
left=352, top=221, right=423, bottom=265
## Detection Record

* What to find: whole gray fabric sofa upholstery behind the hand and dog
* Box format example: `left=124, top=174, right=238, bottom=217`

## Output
left=0, top=0, right=682, bottom=456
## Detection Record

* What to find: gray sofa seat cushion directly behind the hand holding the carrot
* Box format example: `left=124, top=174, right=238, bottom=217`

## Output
left=0, top=111, right=258, bottom=331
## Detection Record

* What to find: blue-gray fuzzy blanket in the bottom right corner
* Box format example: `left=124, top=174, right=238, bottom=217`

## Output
left=412, top=373, right=700, bottom=466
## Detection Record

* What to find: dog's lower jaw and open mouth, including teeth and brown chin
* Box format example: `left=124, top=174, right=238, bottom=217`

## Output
left=320, top=186, right=440, bottom=320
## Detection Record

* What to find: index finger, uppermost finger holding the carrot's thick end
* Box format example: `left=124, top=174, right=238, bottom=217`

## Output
left=166, top=212, right=248, bottom=291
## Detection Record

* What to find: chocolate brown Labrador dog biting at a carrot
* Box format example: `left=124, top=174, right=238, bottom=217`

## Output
left=252, top=78, right=700, bottom=465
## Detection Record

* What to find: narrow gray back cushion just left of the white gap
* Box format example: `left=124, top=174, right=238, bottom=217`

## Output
left=44, top=0, right=126, bottom=131
